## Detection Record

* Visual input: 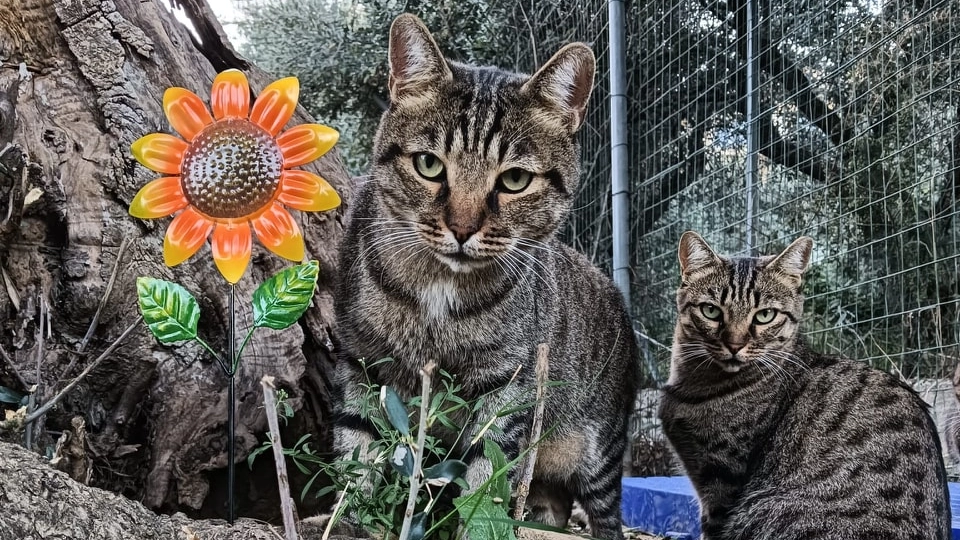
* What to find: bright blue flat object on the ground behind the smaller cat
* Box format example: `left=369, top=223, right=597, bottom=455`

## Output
left=623, top=476, right=960, bottom=540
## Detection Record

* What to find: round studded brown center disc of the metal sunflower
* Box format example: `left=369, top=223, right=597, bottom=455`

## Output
left=180, top=119, right=283, bottom=218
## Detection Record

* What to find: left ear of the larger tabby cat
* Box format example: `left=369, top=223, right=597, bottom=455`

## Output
left=388, top=13, right=451, bottom=102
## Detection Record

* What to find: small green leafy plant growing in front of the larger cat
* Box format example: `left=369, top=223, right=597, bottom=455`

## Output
left=248, top=358, right=555, bottom=540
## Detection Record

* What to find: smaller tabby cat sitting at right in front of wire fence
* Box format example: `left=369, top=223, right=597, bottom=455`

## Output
left=660, top=232, right=950, bottom=540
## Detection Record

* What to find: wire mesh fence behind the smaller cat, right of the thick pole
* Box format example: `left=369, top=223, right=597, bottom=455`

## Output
left=628, top=0, right=960, bottom=470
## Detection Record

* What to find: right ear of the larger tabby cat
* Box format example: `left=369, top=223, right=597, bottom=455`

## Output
left=523, top=43, right=597, bottom=133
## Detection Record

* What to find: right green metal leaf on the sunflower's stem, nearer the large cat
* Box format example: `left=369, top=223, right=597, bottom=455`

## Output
left=253, top=261, right=320, bottom=330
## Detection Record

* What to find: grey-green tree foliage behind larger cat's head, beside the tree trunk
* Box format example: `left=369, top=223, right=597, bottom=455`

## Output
left=239, top=0, right=517, bottom=173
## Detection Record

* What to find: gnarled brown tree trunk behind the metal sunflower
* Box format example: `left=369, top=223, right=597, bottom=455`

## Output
left=0, top=0, right=351, bottom=524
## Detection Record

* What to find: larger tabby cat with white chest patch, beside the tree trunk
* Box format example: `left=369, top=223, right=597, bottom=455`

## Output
left=335, top=15, right=638, bottom=538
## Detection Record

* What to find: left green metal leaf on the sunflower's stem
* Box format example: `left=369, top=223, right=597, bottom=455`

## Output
left=137, top=277, right=200, bottom=343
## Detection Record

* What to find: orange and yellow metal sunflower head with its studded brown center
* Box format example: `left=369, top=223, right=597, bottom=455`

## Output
left=129, top=70, right=340, bottom=284
